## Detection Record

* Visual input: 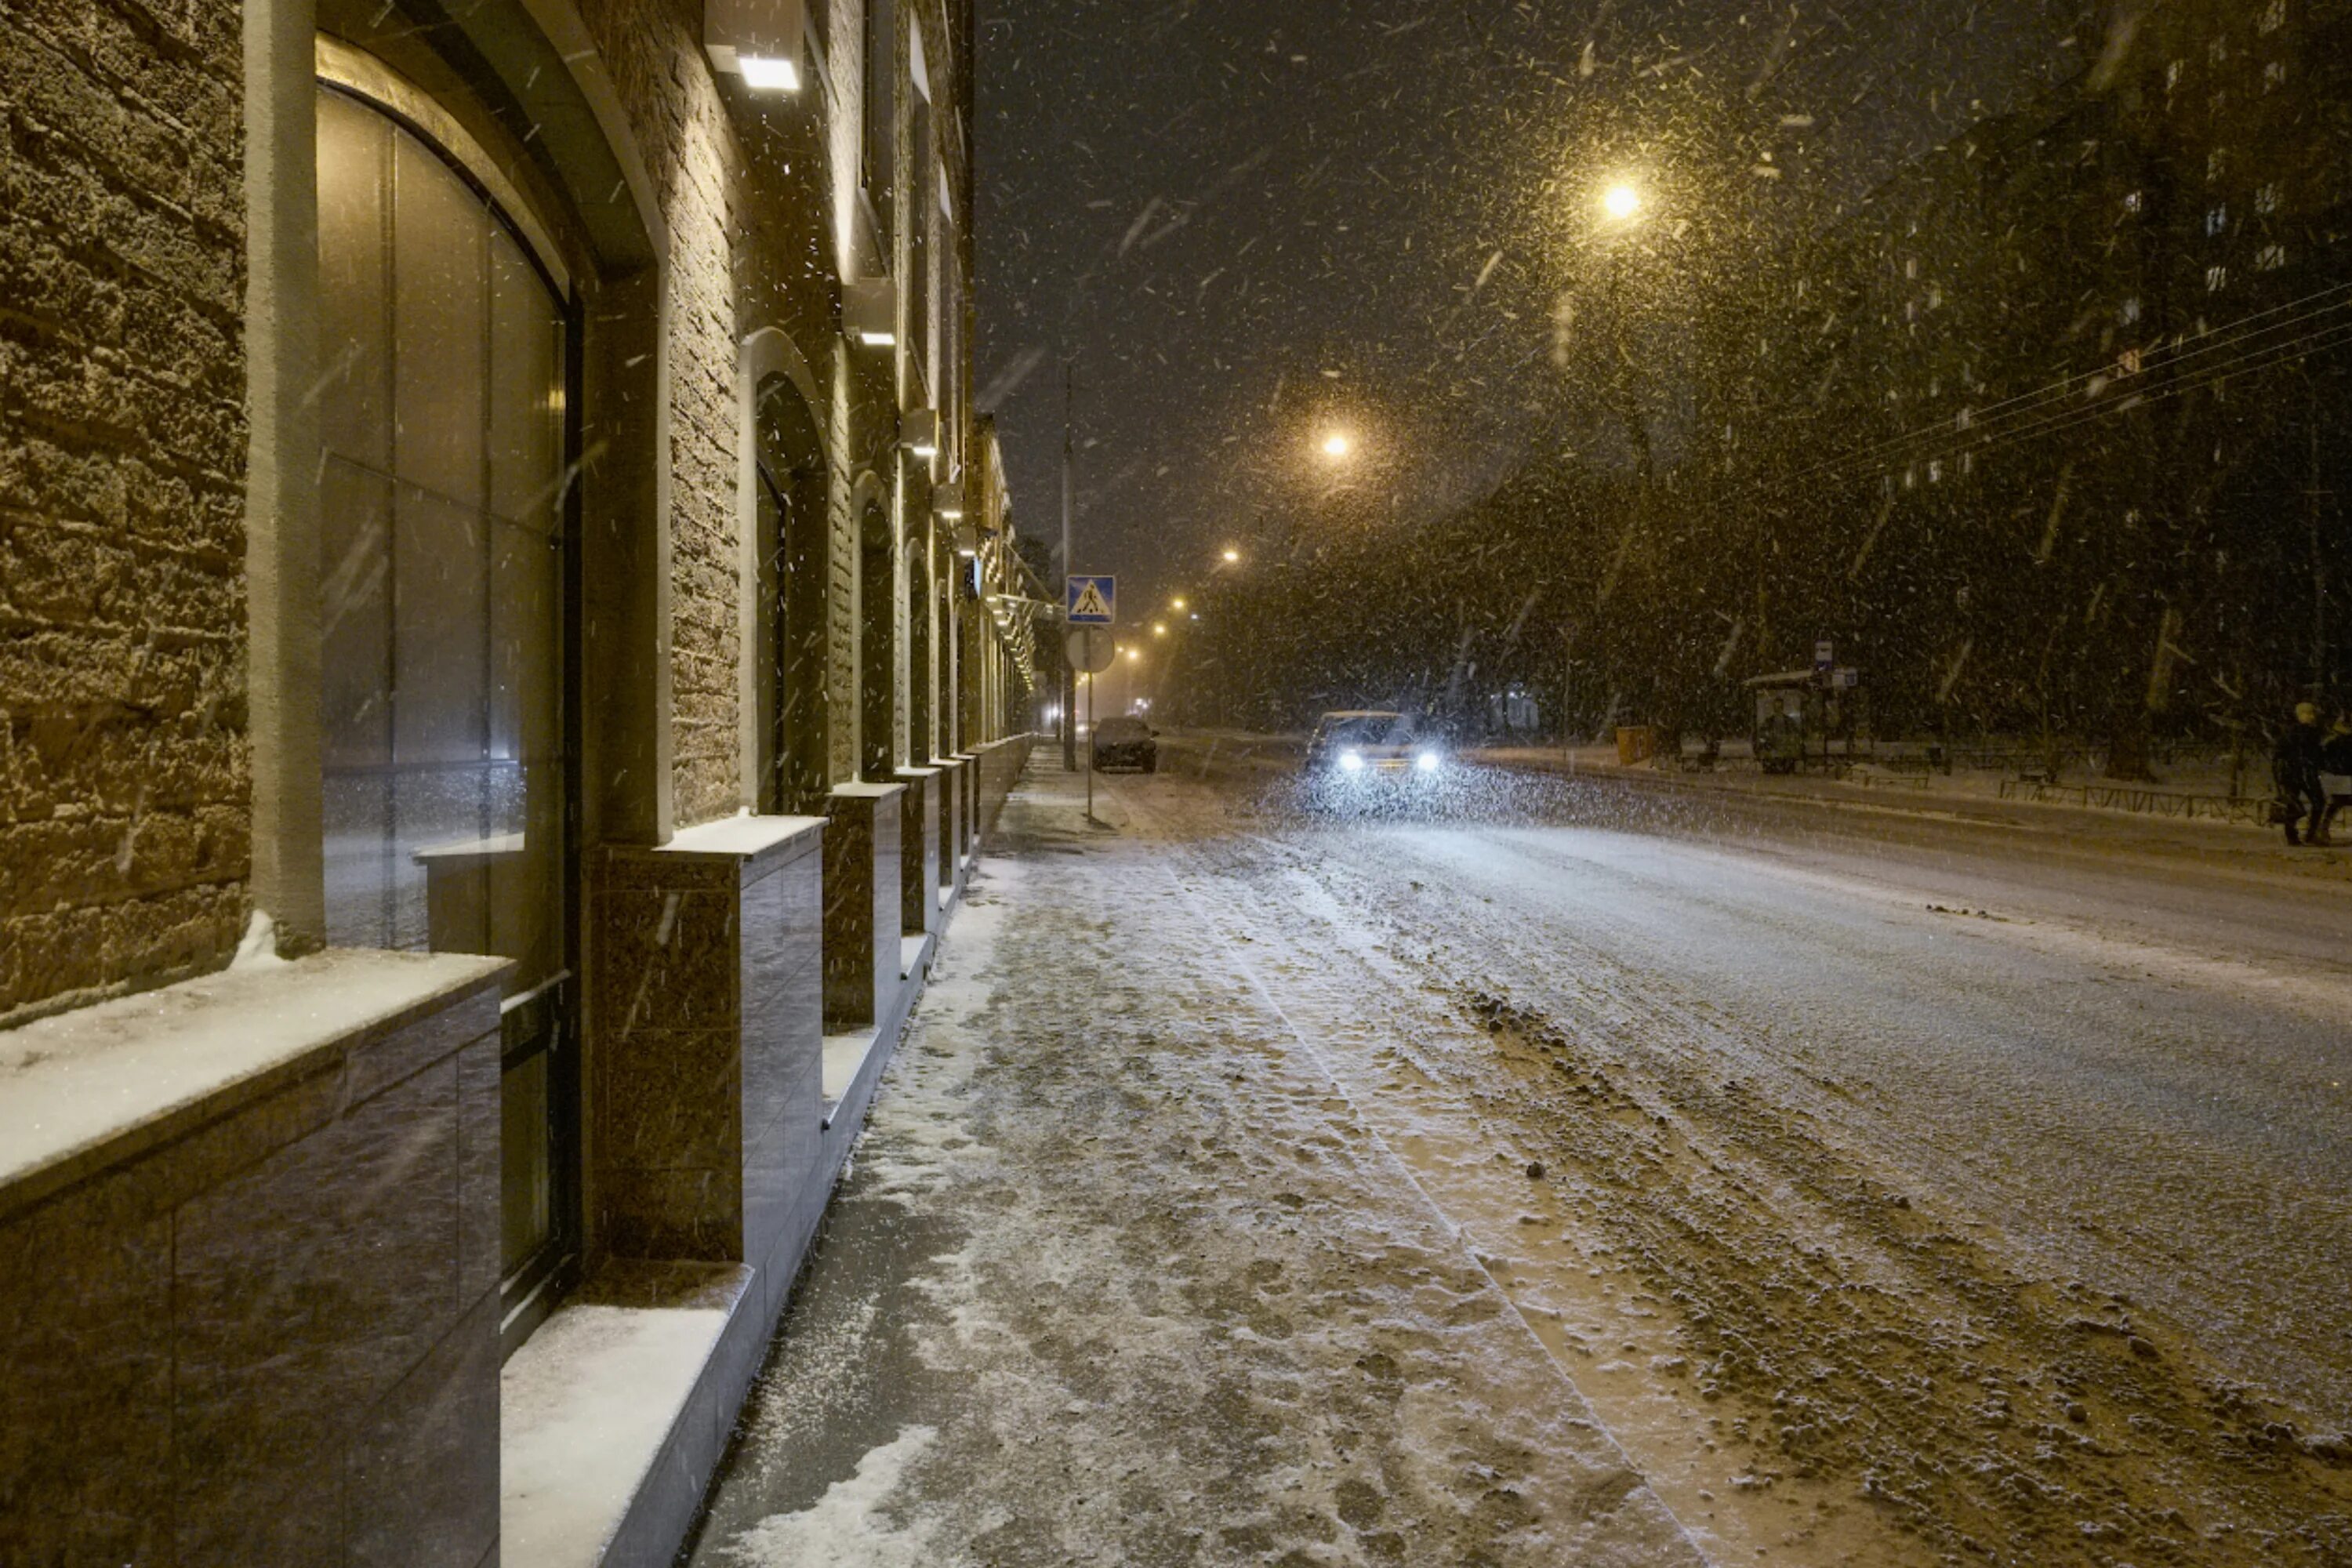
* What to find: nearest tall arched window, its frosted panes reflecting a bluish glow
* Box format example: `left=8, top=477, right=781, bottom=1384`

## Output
left=318, top=87, right=576, bottom=1326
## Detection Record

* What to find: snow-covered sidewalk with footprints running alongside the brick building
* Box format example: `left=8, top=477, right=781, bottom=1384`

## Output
left=694, top=762, right=1700, bottom=1568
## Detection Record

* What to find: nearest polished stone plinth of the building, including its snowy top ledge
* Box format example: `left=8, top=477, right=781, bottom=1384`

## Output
left=0, top=952, right=506, bottom=1568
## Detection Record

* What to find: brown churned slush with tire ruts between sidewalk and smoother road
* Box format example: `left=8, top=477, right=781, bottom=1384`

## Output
left=1127, top=771, right=2352, bottom=1568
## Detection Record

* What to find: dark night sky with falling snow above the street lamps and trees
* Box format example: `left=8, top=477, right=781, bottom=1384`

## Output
left=976, top=0, right=2100, bottom=595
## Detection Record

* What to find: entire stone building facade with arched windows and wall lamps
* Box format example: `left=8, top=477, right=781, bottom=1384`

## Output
left=0, top=0, right=1042, bottom=1568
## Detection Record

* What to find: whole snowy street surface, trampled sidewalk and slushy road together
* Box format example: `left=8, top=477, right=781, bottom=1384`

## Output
left=694, top=739, right=2352, bottom=1568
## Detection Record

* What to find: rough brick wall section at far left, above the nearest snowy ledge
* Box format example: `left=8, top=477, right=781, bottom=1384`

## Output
left=0, top=0, right=252, bottom=1025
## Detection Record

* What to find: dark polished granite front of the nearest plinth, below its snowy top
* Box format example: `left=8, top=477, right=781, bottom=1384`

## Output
left=0, top=985, right=499, bottom=1566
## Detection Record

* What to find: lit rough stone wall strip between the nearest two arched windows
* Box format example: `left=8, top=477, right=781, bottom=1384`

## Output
left=583, top=0, right=743, bottom=825
